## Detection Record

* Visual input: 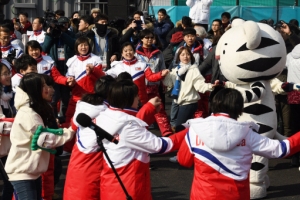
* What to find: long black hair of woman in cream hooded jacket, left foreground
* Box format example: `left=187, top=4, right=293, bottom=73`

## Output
left=19, top=72, right=55, bottom=126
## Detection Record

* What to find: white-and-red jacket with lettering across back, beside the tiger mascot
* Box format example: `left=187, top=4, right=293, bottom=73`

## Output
left=177, top=116, right=300, bottom=200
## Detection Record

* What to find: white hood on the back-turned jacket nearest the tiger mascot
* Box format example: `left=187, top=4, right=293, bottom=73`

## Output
left=189, top=116, right=258, bottom=151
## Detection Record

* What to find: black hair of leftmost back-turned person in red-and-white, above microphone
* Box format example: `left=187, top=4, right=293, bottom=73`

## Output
left=81, top=75, right=115, bottom=105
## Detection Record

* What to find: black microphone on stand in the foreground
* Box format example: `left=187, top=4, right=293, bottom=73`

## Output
left=76, top=113, right=119, bottom=144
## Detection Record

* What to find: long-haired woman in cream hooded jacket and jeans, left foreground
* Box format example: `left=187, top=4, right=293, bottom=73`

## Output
left=5, top=73, right=75, bottom=200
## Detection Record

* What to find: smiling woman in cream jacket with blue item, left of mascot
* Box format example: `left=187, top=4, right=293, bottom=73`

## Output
left=163, top=47, right=214, bottom=131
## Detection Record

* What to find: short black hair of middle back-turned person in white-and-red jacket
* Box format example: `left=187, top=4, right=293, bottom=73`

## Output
left=107, top=80, right=139, bottom=109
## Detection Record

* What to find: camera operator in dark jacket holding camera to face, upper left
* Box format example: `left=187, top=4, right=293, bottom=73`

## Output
left=42, top=17, right=75, bottom=122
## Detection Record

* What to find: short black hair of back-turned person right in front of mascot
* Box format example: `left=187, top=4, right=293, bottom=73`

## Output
left=210, top=88, right=244, bottom=119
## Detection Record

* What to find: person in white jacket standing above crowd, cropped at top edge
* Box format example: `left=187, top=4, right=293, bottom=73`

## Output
left=186, top=0, right=213, bottom=30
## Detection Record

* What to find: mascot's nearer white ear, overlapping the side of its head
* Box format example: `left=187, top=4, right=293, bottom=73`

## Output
left=243, top=21, right=261, bottom=50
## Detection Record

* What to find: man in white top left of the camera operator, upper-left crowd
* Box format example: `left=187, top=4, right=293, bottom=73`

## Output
left=28, top=17, right=46, bottom=46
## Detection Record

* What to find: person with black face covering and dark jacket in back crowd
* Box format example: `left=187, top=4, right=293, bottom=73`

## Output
left=92, top=14, right=120, bottom=68
